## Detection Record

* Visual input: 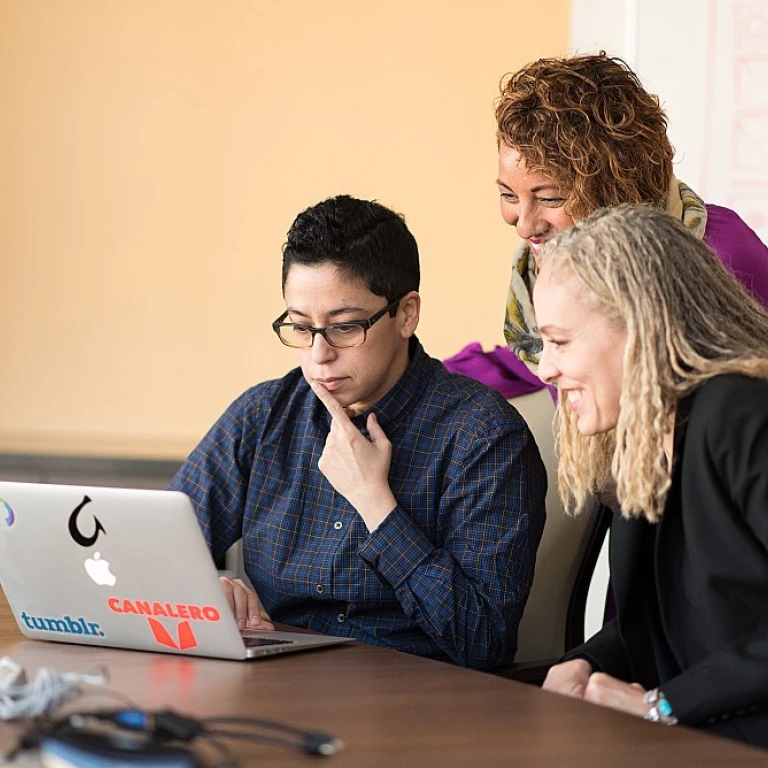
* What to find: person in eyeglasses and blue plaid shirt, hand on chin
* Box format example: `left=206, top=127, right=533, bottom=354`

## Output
left=171, top=195, right=546, bottom=668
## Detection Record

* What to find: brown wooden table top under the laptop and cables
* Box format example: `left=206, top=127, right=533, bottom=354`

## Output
left=0, top=592, right=768, bottom=768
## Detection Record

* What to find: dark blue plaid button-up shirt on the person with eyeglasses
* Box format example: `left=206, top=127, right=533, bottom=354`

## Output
left=171, top=339, right=546, bottom=668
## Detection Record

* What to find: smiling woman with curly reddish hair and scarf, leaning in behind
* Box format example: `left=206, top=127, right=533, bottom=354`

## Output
left=496, top=52, right=768, bottom=372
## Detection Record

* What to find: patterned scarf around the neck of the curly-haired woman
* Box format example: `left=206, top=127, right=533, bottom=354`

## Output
left=504, top=177, right=707, bottom=373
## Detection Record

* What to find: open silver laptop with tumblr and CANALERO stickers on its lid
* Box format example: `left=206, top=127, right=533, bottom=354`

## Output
left=0, top=482, right=354, bottom=659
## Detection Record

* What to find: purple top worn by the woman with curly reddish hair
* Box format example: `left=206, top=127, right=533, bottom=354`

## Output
left=443, top=205, right=768, bottom=399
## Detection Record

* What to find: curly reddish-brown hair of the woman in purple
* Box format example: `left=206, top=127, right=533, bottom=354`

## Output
left=496, top=51, right=674, bottom=219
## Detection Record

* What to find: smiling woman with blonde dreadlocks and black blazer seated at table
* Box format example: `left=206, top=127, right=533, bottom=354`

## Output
left=533, top=206, right=768, bottom=747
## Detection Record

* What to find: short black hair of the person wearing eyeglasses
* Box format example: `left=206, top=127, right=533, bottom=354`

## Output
left=283, top=195, right=420, bottom=302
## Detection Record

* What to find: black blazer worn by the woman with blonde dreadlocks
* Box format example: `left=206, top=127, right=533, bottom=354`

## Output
left=566, top=376, right=768, bottom=746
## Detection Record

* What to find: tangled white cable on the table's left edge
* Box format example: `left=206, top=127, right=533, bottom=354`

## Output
left=0, top=656, right=107, bottom=720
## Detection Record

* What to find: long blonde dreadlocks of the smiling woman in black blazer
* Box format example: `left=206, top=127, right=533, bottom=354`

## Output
left=542, top=205, right=768, bottom=522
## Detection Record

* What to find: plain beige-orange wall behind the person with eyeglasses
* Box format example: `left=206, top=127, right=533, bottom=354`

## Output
left=0, top=0, right=568, bottom=457
